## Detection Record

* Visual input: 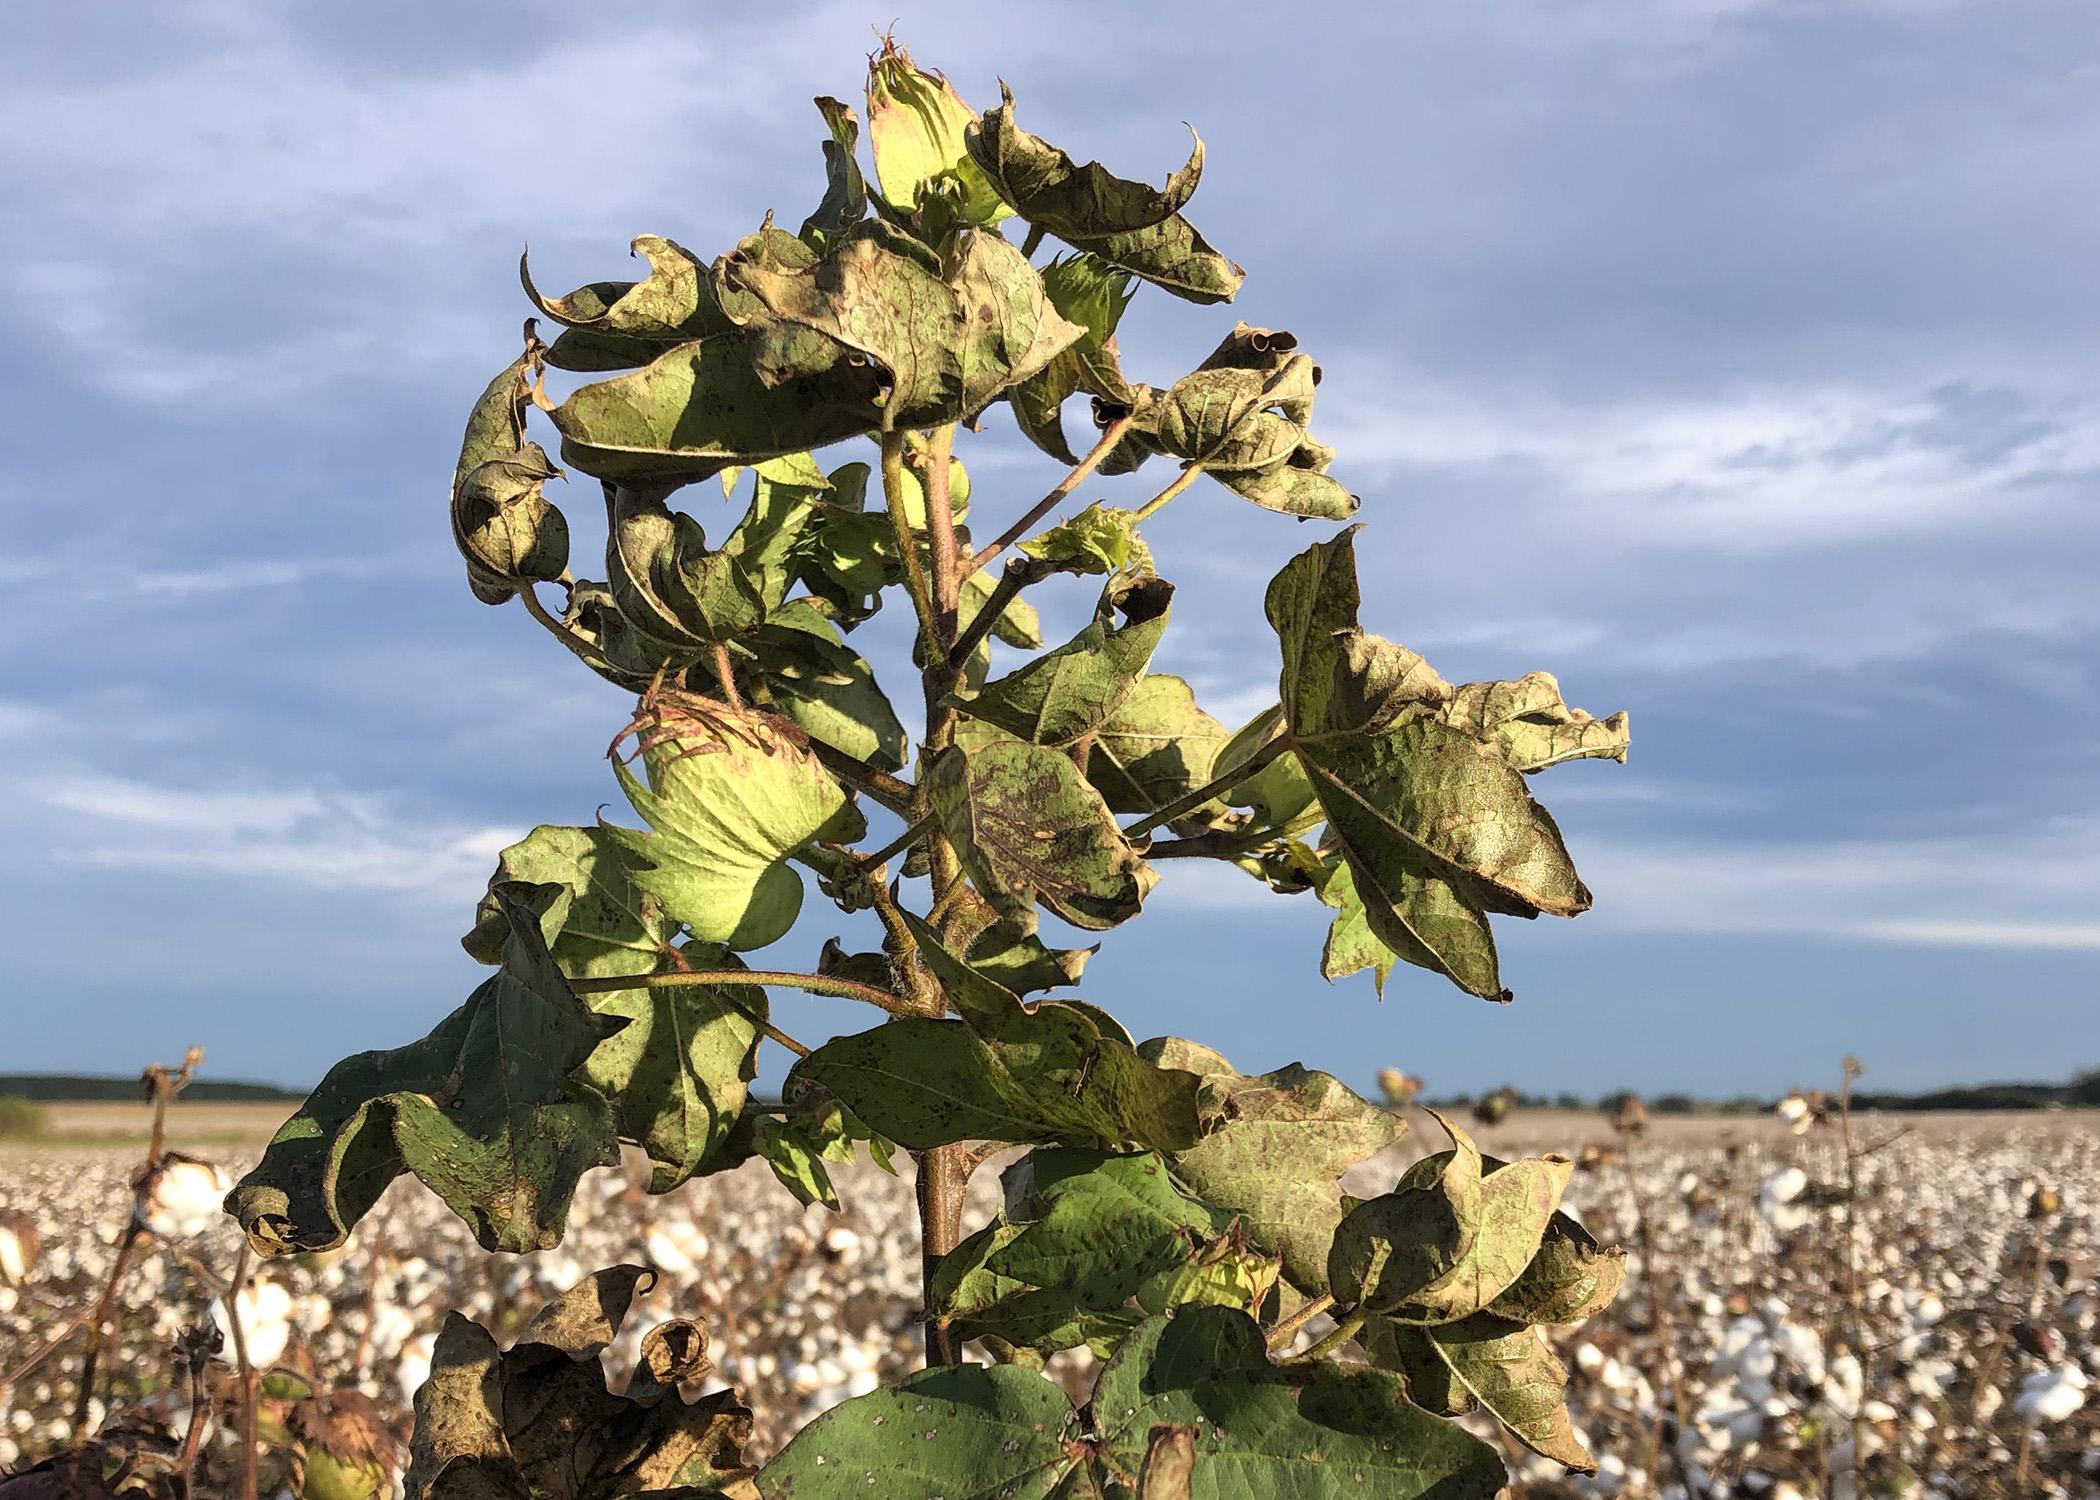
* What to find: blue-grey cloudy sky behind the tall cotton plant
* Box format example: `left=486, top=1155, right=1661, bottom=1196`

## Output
left=0, top=0, right=2100, bottom=1095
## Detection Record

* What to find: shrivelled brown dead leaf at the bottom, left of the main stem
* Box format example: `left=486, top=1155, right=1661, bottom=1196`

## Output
left=405, top=1265, right=754, bottom=1500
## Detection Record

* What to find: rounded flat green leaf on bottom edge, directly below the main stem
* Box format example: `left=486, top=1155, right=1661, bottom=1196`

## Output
left=758, top=1366, right=1075, bottom=1500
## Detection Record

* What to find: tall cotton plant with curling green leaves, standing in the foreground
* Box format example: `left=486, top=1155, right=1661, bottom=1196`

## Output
left=241, top=38, right=1628, bottom=1500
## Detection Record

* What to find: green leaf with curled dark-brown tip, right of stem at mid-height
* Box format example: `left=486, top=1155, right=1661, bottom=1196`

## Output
left=951, top=578, right=1174, bottom=748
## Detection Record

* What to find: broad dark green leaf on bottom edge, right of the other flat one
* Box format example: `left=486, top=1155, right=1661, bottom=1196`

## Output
left=1090, top=1307, right=1506, bottom=1500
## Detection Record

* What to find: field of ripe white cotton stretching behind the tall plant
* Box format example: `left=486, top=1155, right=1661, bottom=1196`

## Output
left=0, top=1105, right=2100, bottom=1500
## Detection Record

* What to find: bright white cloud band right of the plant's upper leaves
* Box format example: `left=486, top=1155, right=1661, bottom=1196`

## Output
left=1327, top=370, right=2100, bottom=555
